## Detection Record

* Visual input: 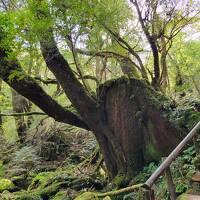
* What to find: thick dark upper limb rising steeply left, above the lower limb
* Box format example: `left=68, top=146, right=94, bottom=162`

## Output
left=34, top=1, right=102, bottom=127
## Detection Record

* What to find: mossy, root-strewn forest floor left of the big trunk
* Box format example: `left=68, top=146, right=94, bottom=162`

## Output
left=0, top=118, right=106, bottom=200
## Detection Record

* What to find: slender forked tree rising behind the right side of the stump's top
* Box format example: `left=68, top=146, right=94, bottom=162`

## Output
left=131, top=0, right=199, bottom=88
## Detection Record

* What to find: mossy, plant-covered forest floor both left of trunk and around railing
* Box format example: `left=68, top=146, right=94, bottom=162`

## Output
left=0, top=95, right=200, bottom=200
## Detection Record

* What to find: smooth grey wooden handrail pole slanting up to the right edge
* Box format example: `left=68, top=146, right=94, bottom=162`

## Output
left=144, top=121, right=200, bottom=189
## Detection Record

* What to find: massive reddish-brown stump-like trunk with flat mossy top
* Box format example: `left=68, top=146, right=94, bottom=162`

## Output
left=95, top=78, right=182, bottom=181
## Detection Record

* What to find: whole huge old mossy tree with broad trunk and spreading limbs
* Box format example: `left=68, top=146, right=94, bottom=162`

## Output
left=0, top=1, right=200, bottom=183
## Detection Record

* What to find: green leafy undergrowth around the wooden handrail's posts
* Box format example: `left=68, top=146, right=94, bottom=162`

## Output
left=131, top=145, right=197, bottom=200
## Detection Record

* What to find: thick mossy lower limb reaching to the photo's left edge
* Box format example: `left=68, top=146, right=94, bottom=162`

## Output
left=0, top=47, right=89, bottom=130
